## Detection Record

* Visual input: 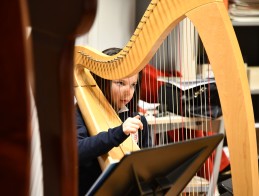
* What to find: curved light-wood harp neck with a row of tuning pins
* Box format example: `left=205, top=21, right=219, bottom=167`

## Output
left=75, top=0, right=220, bottom=80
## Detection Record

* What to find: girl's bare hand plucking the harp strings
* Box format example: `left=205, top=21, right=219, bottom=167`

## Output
left=122, top=115, right=143, bottom=135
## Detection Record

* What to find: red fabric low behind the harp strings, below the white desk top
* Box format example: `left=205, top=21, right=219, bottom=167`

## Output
left=168, top=129, right=230, bottom=180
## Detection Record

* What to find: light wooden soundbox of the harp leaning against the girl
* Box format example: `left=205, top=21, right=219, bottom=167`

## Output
left=74, top=66, right=139, bottom=169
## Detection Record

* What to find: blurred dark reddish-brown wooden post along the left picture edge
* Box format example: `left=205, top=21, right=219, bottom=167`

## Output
left=0, top=1, right=31, bottom=195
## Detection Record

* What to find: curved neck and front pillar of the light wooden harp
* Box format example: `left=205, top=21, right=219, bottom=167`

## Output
left=75, top=0, right=259, bottom=195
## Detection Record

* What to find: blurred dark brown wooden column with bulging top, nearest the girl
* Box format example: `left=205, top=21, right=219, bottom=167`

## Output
left=26, top=0, right=97, bottom=196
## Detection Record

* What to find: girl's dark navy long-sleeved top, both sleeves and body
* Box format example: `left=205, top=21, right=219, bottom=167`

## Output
left=76, top=106, right=152, bottom=196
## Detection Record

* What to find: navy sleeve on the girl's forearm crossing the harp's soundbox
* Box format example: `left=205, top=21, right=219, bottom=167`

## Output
left=76, top=106, right=128, bottom=163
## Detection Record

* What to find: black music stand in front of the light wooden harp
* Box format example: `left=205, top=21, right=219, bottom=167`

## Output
left=86, top=134, right=224, bottom=196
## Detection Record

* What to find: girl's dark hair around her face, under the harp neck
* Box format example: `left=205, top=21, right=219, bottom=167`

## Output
left=92, top=48, right=142, bottom=115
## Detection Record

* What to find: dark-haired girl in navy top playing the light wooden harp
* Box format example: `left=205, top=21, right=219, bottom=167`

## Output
left=76, top=48, right=151, bottom=195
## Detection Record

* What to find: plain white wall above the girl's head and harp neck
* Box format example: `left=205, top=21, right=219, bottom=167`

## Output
left=76, top=0, right=136, bottom=51
